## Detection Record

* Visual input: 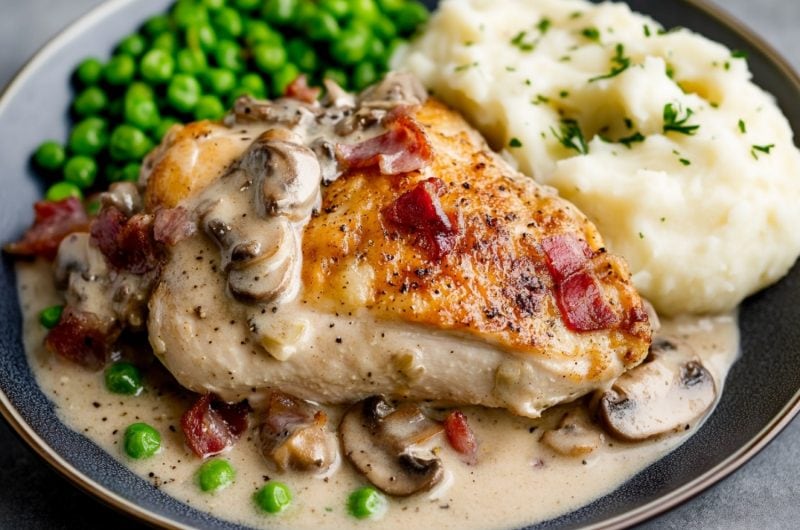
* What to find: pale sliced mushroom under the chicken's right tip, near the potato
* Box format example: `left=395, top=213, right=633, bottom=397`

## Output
left=599, top=339, right=717, bottom=441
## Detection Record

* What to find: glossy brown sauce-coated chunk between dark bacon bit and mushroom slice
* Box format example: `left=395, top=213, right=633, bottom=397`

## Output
left=259, top=392, right=336, bottom=471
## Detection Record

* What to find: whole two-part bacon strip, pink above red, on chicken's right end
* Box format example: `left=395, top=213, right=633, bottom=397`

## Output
left=542, top=234, right=620, bottom=331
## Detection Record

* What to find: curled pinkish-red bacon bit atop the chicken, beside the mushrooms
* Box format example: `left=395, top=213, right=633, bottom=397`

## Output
left=336, top=112, right=432, bottom=175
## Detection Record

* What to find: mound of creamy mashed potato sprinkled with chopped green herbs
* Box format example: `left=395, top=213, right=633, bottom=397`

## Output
left=397, top=0, right=800, bottom=314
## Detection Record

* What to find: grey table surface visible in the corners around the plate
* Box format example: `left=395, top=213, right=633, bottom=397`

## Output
left=0, top=0, right=800, bottom=529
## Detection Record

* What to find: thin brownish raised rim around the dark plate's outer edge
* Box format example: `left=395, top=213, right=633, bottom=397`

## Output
left=0, top=0, right=800, bottom=530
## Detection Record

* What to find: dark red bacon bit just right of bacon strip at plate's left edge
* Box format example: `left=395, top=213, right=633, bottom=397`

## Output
left=91, top=206, right=160, bottom=274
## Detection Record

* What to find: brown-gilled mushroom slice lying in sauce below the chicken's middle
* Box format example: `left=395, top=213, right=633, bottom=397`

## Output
left=339, top=396, right=443, bottom=496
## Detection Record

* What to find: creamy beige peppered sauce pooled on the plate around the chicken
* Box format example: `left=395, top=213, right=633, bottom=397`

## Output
left=17, top=263, right=739, bottom=529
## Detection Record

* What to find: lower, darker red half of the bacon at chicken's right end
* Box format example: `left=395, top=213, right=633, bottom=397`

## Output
left=556, top=271, right=620, bottom=331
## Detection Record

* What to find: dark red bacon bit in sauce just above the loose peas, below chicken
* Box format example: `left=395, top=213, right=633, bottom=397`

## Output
left=181, top=394, right=250, bottom=458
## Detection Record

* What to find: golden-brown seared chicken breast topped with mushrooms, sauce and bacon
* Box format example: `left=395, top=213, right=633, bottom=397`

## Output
left=145, top=75, right=650, bottom=417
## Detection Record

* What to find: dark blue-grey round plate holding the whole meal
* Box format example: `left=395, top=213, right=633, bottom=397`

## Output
left=0, top=0, right=800, bottom=529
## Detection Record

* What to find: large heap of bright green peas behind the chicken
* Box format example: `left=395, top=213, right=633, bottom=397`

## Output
left=28, top=0, right=428, bottom=201
